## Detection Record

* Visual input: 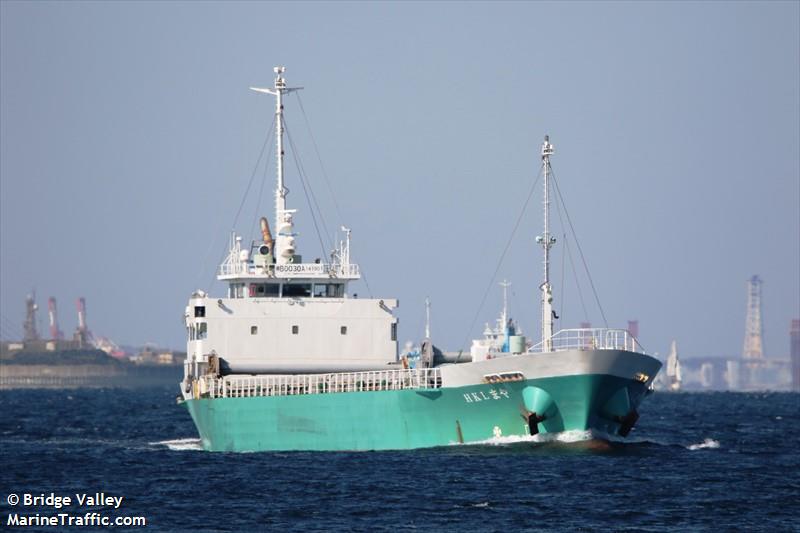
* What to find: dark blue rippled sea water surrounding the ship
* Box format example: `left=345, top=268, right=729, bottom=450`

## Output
left=0, top=386, right=800, bottom=532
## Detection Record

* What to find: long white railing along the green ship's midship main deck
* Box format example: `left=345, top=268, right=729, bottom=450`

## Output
left=194, top=368, right=442, bottom=398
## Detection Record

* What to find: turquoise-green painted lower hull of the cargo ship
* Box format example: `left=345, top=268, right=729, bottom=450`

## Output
left=185, top=374, right=646, bottom=452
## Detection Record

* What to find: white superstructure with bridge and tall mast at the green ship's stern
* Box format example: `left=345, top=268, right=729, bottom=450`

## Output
left=184, top=67, right=398, bottom=376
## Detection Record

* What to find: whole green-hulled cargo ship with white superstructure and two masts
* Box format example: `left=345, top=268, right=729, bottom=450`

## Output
left=178, top=67, right=661, bottom=452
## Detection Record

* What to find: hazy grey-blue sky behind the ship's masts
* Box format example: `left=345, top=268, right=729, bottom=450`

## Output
left=0, top=1, right=800, bottom=356
